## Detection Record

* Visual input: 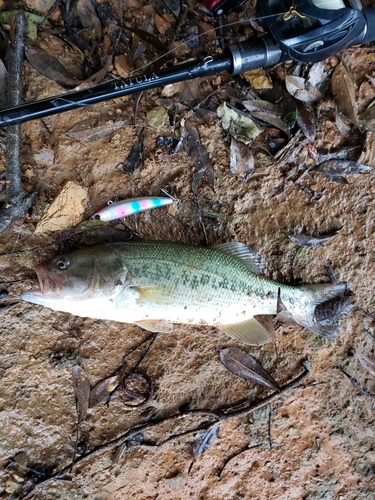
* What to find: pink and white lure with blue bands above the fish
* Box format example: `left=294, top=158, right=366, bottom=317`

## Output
left=91, top=196, right=176, bottom=222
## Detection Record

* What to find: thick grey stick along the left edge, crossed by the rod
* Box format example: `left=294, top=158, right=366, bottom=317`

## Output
left=0, top=12, right=36, bottom=233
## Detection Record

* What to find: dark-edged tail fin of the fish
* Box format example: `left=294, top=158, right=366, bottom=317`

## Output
left=278, top=283, right=354, bottom=339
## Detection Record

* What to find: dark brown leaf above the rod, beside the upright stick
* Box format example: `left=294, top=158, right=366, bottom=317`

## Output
left=25, top=47, right=81, bottom=89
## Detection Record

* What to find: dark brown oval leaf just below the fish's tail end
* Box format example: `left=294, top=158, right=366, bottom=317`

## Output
left=220, top=347, right=280, bottom=391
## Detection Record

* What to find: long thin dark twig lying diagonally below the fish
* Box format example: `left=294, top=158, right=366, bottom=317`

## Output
left=22, top=368, right=310, bottom=500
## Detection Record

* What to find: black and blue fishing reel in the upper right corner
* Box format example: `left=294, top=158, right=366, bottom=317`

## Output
left=206, top=0, right=375, bottom=63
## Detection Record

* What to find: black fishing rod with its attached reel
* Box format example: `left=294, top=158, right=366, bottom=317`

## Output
left=0, top=0, right=375, bottom=127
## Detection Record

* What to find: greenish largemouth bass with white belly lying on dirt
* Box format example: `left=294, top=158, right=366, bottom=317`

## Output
left=21, top=242, right=345, bottom=345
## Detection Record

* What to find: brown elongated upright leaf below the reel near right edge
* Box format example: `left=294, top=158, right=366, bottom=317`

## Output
left=332, top=63, right=358, bottom=126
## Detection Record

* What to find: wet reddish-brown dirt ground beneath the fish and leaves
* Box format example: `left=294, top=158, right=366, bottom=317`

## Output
left=0, top=0, right=375, bottom=500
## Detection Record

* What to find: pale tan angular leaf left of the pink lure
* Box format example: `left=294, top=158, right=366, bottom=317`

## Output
left=35, top=181, right=89, bottom=234
